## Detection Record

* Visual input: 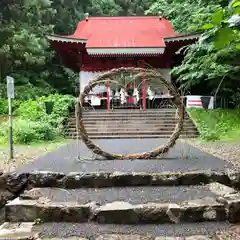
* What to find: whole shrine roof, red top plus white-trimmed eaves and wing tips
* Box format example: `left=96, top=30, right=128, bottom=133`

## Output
left=48, top=16, right=198, bottom=56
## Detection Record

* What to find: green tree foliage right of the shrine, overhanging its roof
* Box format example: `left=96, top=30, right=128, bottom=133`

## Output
left=147, top=0, right=240, bottom=103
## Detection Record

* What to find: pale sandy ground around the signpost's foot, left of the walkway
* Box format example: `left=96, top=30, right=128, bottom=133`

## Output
left=0, top=139, right=69, bottom=171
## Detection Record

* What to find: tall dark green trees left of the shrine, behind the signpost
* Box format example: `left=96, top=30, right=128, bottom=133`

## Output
left=0, top=0, right=55, bottom=98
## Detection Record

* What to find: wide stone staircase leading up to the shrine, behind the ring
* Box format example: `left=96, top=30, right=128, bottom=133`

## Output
left=65, top=109, right=198, bottom=139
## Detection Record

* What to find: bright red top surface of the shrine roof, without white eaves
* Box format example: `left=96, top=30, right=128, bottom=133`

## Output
left=68, top=17, right=178, bottom=48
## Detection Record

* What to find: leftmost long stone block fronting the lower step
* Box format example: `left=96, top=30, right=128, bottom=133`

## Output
left=5, top=198, right=92, bottom=222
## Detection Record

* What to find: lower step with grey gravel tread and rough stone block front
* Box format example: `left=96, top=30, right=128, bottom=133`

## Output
left=5, top=182, right=240, bottom=225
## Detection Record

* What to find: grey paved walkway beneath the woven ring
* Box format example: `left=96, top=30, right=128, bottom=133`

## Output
left=19, top=139, right=233, bottom=173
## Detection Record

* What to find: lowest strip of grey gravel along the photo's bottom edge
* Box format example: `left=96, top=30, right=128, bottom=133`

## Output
left=40, top=222, right=231, bottom=240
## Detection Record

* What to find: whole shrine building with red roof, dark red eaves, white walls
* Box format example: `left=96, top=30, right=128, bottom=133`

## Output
left=48, top=16, right=198, bottom=111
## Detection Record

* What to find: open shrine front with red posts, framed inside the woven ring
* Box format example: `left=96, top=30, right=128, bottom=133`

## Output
left=81, top=69, right=173, bottom=111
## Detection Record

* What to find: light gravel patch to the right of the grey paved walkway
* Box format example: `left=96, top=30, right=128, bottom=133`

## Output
left=188, top=141, right=240, bottom=168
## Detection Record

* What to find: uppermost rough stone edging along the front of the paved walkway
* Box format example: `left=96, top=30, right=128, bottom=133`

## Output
left=0, top=170, right=240, bottom=191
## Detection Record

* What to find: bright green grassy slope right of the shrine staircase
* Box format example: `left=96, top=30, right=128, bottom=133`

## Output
left=189, top=109, right=240, bottom=143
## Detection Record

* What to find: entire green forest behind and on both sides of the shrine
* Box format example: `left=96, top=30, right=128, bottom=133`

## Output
left=0, top=0, right=240, bottom=106
